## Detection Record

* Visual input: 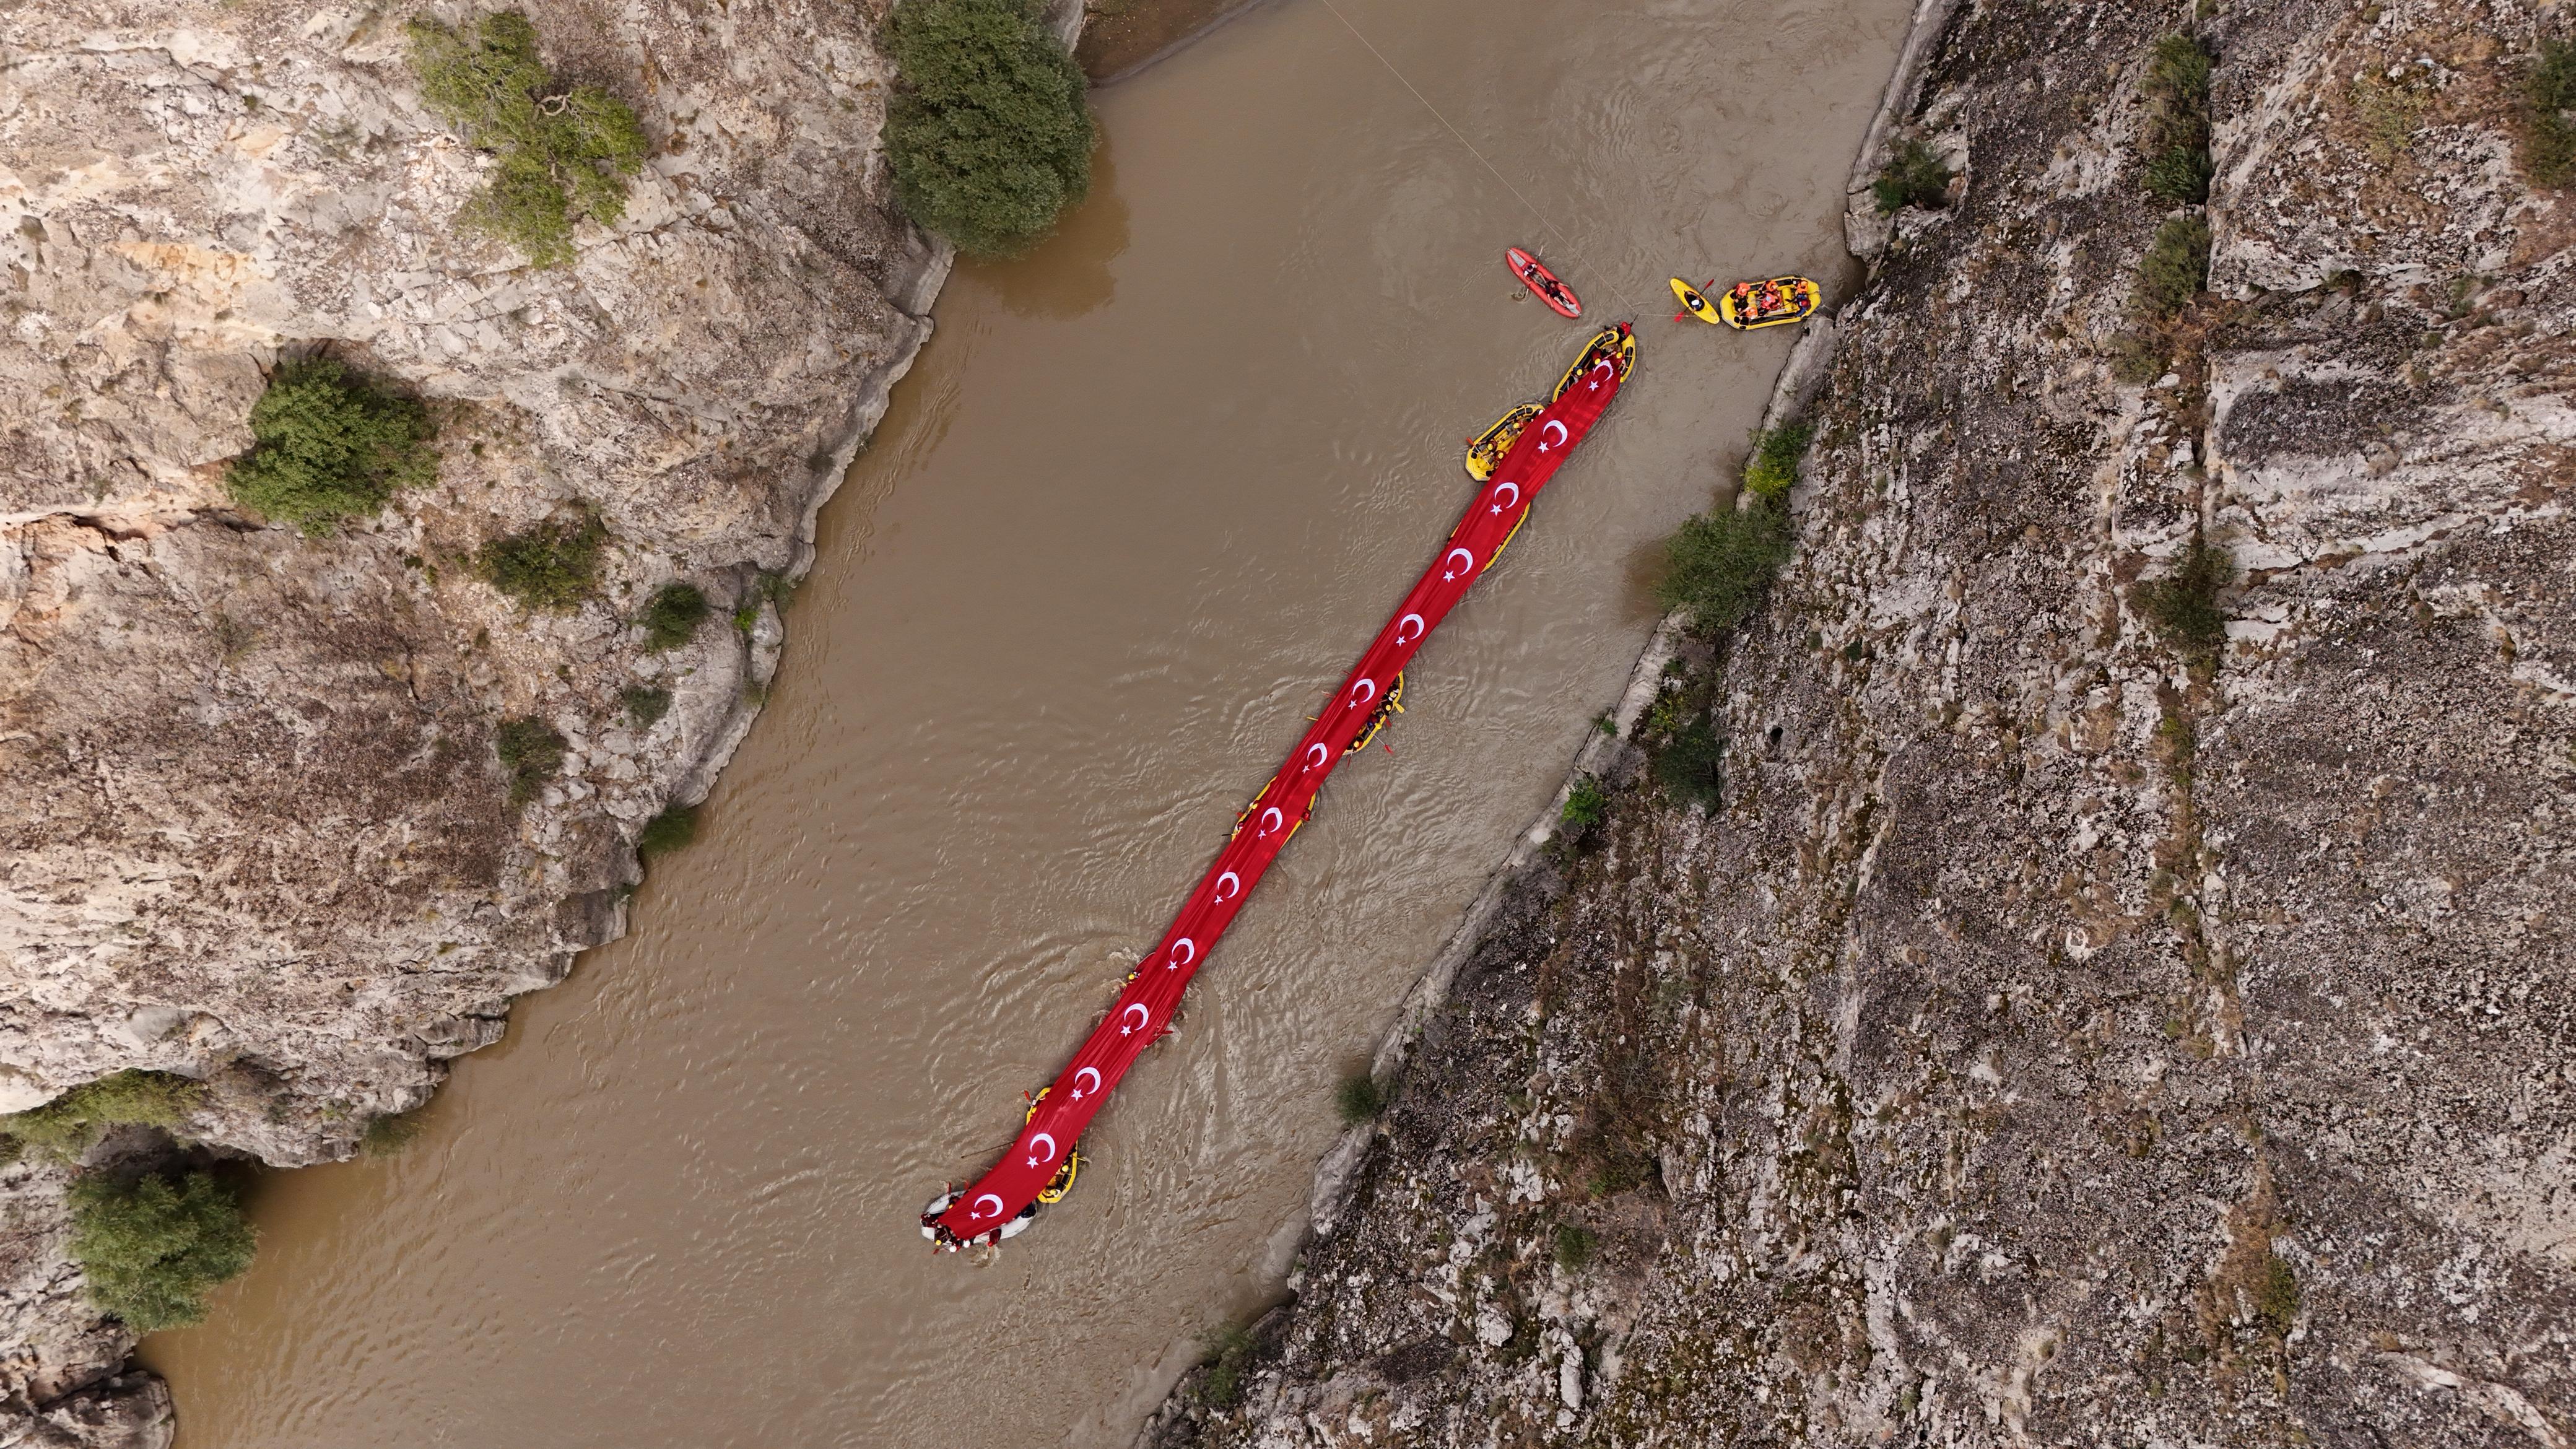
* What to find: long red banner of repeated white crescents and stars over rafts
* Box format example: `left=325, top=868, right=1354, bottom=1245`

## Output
left=938, top=325, right=1625, bottom=1240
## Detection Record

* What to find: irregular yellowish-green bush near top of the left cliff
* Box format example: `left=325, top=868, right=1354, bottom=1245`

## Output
left=402, top=11, right=651, bottom=266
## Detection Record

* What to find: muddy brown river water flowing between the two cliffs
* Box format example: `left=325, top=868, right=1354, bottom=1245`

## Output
left=147, top=0, right=1906, bottom=1449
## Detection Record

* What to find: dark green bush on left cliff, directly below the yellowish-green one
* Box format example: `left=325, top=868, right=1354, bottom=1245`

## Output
left=224, top=359, right=438, bottom=534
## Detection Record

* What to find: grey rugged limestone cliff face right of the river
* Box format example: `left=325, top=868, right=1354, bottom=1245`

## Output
left=1149, top=0, right=2576, bottom=1449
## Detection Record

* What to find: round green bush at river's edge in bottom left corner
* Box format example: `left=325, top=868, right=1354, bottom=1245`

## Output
left=69, top=1173, right=258, bottom=1333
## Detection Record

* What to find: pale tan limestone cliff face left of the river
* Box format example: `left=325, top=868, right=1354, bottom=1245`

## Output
left=0, top=0, right=968, bottom=1444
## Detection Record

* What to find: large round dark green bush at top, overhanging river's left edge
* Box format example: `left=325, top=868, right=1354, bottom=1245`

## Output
left=886, top=0, right=1095, bottom=255
